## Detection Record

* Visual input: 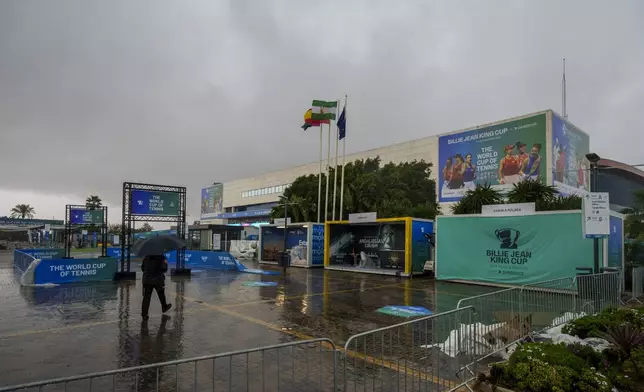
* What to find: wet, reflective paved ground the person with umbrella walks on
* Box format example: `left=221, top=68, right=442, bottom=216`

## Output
left=0, top=251, right=492, bottom=391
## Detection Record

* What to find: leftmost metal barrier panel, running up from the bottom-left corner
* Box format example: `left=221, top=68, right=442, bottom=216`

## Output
left=0, top=339, right=338, bottom=392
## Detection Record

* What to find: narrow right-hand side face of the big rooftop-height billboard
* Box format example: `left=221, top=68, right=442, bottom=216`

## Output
left=551, top=113, right=590, bottom=196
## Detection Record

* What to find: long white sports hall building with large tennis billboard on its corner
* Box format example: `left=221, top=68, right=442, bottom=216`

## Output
left=201, top=110, right=644, bottom=226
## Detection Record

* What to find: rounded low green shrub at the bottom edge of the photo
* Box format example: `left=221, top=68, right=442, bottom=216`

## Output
left=493, top=343, right=611, bottom=392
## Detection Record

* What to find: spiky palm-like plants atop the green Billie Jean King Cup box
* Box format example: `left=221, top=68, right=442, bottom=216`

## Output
left=452, top=178, right=582, bottom=215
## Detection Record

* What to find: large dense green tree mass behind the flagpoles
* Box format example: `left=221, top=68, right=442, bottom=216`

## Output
left=271, top=157, right=439, bottom=222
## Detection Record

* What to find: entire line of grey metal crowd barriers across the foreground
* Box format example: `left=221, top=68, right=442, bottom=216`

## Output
left=0, top=268, right=624, bottom=392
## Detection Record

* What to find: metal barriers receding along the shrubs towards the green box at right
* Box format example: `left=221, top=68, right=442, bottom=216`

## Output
left=457, top=272, right=621, bottom=381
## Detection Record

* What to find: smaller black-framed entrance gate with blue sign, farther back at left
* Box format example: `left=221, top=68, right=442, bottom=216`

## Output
left=65, top=204, right=107, bottom=259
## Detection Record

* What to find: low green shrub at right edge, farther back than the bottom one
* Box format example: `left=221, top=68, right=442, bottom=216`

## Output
left=562, top=308, right=644, bottom=339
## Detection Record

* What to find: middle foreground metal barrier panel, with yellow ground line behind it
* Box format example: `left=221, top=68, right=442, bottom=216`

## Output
left=341, top=307, right=474, bottom=391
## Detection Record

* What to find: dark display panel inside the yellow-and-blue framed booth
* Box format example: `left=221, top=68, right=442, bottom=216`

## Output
left=329, top=222, right=405, bottom=270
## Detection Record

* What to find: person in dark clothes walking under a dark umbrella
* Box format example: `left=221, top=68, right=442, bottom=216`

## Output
left=132, top=235, right=186, bottom=320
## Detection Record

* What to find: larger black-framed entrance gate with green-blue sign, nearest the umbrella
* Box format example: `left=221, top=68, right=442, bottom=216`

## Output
left=115, top=182, right=190, bottom=279
